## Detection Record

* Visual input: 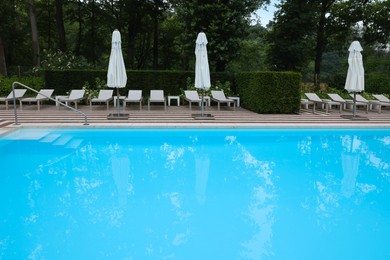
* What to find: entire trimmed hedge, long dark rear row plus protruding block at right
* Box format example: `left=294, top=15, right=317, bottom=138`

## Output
left=45, top=70, right=302, bottom=114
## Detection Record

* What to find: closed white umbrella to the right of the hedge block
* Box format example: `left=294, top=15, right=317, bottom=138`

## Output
left=345, top=41, right=364, bottom=117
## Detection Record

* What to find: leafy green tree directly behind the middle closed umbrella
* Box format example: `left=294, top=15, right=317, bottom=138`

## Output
left=171, top=0, right=269, bottom=71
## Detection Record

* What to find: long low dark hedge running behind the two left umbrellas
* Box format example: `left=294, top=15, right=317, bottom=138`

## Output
left=45, top=70, right=233, bottom=95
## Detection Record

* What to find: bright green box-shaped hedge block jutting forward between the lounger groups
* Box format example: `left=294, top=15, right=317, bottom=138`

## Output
left=236, top=72, right=302, bottom=114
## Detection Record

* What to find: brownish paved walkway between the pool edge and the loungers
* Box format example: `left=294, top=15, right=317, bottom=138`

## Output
left=0, top=102, right=390, bottom=133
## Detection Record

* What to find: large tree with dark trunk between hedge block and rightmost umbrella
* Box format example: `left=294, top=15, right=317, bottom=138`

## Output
left=269, top=0, right=380, bottom=88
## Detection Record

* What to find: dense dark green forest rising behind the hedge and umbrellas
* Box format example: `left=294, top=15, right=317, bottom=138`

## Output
left=0, top=0, right=390, bottom=89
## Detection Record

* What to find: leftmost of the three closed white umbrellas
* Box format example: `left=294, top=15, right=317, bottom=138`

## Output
left=107, top=30, right=127, bottom=115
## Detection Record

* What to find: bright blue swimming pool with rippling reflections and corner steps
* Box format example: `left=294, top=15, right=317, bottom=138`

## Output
left=0, top=128, right=390, bottom=259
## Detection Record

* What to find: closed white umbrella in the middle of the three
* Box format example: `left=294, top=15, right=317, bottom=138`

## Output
left=195, top=32, right=211, bottom=115
